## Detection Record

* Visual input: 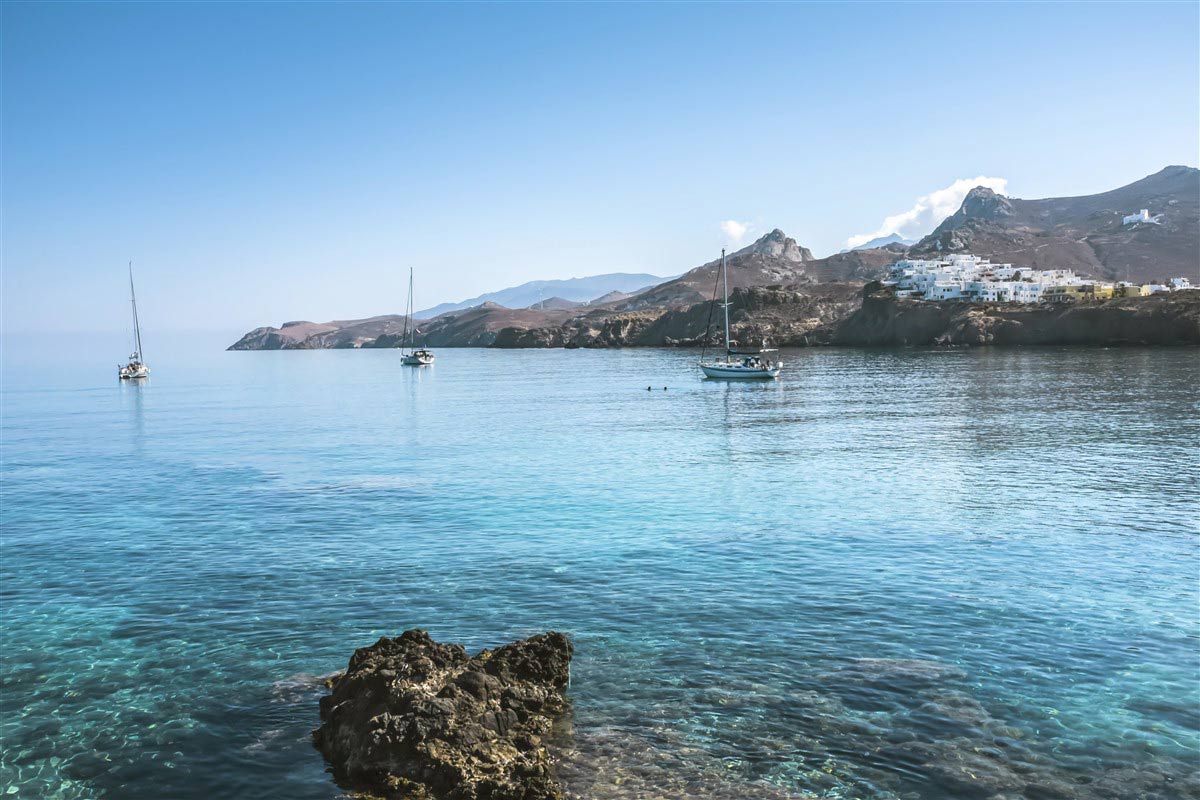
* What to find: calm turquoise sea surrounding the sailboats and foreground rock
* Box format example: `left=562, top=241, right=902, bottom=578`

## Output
left=0, top=345, right=1200, bottom=799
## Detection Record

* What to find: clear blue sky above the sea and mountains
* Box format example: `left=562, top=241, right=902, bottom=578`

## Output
left=0, top=1, right=1200, bottom=335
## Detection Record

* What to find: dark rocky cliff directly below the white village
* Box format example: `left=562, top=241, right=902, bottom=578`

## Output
left=814, top=283, right=1200, bottom=347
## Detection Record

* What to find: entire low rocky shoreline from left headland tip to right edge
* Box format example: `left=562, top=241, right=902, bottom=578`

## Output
left=229, top=282, right=1200, bottom=350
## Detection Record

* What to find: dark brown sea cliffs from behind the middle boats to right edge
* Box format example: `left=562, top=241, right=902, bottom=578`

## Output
left=482, top=289, right=1200, bottom=348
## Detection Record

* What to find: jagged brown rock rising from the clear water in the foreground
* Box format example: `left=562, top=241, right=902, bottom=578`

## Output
left=313, top=631, right=571, bottom=800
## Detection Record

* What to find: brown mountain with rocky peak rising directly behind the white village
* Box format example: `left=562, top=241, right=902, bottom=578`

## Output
left=908, top=167, right=1200, bottom=282
